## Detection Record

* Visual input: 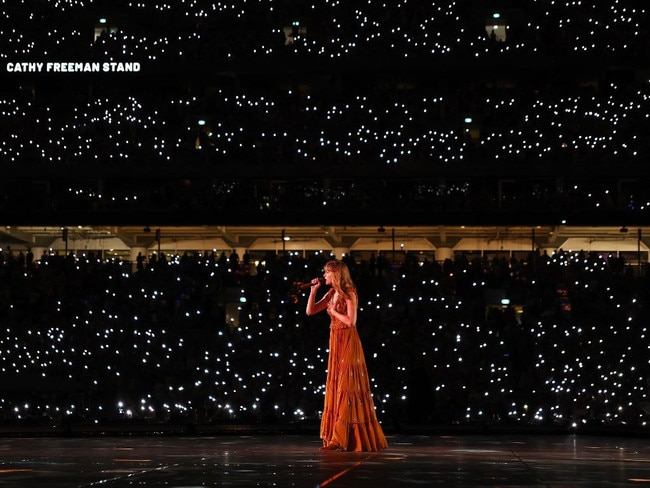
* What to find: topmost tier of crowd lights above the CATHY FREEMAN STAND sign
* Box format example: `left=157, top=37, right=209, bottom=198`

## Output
left=1, top=0, right=648, bottom=62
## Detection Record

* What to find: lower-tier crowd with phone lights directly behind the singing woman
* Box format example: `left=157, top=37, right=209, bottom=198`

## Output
left=0, top=249, right=650, bottom=429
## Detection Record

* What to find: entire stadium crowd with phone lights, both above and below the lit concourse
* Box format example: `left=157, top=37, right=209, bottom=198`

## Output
left=0, top=0, right=650, bottom=427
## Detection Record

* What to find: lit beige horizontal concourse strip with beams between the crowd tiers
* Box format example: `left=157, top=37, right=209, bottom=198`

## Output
left=0, top=225, right=650, bottom=262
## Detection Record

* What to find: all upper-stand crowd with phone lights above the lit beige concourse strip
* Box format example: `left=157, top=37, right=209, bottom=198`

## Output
left=0, top=0, right=650, bottom=219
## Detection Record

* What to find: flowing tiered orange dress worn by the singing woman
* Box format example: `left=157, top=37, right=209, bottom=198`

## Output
left=320, top=289, right=388, bottom=451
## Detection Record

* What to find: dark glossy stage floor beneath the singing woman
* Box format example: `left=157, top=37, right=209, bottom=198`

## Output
left=0, top=434, right=650, bottom=488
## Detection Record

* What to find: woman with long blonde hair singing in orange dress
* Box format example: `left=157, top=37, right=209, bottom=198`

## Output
left=307, top=261, right=388, bottom=451
